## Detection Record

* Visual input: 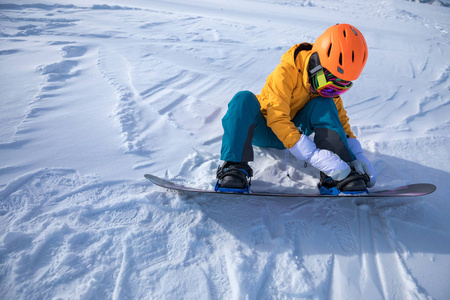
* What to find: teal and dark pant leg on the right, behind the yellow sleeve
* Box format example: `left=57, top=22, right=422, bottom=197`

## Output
left=293, top=97, right=355, bottom=162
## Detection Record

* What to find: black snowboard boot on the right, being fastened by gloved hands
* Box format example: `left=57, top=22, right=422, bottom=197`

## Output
left=318, top=171, right=370, bottom=195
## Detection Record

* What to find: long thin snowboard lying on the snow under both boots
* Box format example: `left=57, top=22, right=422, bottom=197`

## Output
left=144, top=174, right=436, bottom=198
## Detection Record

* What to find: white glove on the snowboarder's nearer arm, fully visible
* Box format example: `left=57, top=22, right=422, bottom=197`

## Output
left=289, top=134, right=351, bottom=181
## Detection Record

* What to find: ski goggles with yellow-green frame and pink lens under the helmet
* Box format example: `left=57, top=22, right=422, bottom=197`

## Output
left=310, top=68, right=353, bottom=97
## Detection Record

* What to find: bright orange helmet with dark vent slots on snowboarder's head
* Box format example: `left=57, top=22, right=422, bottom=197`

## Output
left=312, top=24, right=368, bottom=81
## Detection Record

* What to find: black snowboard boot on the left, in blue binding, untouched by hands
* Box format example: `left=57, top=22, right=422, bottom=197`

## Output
left=214, top=161, right=253, bottom=193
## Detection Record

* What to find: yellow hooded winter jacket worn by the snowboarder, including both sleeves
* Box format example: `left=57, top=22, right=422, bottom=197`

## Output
left=256, top=43, right=355, bottom=148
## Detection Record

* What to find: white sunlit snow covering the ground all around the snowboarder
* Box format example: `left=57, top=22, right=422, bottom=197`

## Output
left=0, top=0, right=450, bottom=299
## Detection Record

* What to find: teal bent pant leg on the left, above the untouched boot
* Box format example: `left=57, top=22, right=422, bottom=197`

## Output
left=220, top=91, right=261, bottom=162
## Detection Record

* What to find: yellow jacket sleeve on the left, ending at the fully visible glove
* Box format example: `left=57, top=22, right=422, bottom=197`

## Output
left=266, top=63, right=301, bottom=148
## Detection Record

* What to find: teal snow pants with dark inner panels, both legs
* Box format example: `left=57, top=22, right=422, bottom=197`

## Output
left=221, top=91, right=355, bottom=162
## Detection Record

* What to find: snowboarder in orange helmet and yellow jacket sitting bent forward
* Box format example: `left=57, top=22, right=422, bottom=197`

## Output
left=216, top=24, right=376, bottom=194
